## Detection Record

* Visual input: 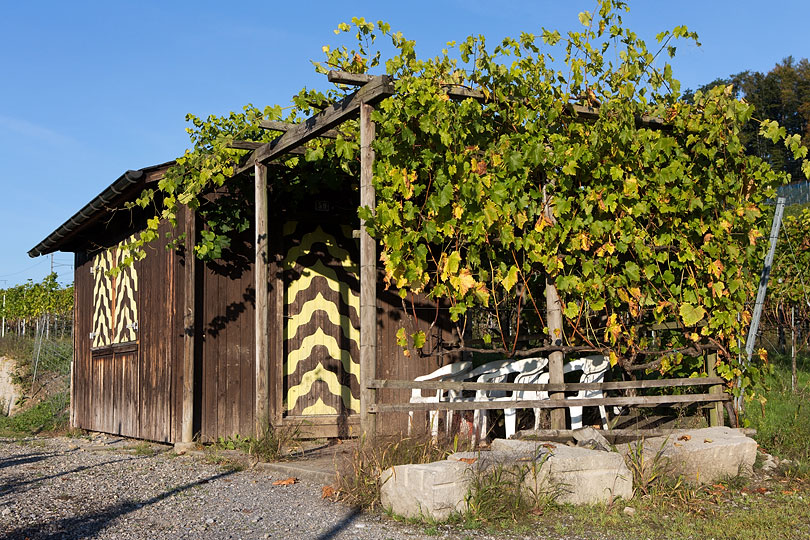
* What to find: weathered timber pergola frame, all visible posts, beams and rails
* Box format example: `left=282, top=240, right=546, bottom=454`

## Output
left=181, top=71, right=727, bottom=443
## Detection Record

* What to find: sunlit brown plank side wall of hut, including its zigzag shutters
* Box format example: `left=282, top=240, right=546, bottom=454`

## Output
left=71, top=217, right=182, bottom=442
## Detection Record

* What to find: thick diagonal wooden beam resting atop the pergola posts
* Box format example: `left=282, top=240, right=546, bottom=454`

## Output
left=236, top=75, right=394, bottom=173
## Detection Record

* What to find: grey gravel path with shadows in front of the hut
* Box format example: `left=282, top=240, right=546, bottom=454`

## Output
left=0, top=438, right=487, bottom=540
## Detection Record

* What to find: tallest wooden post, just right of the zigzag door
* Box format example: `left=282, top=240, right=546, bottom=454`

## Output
left=360, top=103, right=377, bottom=439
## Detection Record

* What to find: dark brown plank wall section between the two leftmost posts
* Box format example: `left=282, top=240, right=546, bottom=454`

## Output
left=198, top=231, right=255, bottom=441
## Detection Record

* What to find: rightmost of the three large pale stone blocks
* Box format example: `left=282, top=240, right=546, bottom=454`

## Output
left=631, top=427, right=757, bottom=484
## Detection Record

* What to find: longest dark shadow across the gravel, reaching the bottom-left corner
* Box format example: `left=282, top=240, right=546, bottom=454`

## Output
left=5, top=471, right=237, bottom=540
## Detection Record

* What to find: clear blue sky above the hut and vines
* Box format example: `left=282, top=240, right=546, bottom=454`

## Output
left=0, top=0, right=810, bottom=288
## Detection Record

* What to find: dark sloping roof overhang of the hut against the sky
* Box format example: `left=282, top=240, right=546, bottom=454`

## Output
left=28, top=161, right=174, bottom=257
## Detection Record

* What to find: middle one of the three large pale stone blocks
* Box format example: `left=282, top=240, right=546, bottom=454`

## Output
left=492, top=439, right=633, bottom=504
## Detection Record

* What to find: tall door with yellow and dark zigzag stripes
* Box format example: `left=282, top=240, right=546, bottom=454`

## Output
left=283, top=222, right=360, bottom=415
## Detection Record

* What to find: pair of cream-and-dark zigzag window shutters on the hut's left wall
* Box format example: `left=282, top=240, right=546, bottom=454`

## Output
left=91, top=237, right=138, bottom=348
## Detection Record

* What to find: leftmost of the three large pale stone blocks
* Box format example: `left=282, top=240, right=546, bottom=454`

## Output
left=380, top=461, right=471, bottom=520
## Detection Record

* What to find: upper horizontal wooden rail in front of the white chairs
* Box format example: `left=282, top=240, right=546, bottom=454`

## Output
left=368, top=377, right=725, bottom=393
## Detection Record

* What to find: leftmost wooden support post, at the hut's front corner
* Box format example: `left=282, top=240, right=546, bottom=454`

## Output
left=180, top=207, right=197, bottom=444
